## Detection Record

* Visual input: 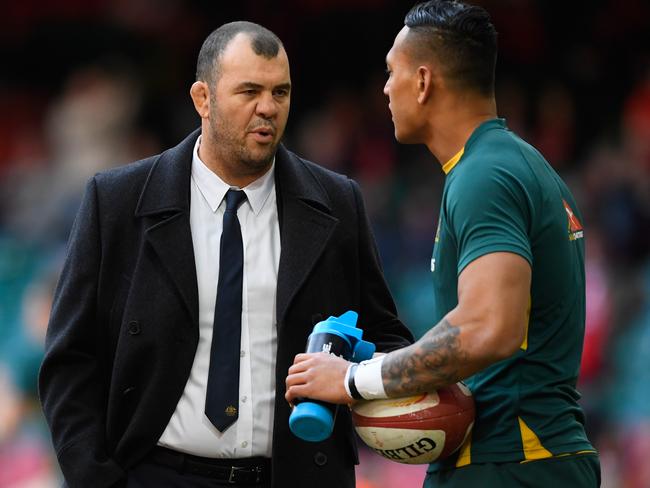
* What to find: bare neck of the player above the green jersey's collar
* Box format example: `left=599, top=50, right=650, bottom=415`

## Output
left=426, top=97, right=497, bottom=166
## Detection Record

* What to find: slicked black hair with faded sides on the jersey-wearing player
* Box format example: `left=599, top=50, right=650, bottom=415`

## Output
left=404, top=0, right=497, bottom=95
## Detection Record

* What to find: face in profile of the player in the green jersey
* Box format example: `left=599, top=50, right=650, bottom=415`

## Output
left=384, top=26, right=423, bottom=144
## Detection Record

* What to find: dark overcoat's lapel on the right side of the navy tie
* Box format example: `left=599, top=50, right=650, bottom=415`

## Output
left=275, top=146, right=338, bottom=324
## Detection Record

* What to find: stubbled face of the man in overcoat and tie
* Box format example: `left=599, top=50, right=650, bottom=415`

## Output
left=209, top=34, right=291, bottom=175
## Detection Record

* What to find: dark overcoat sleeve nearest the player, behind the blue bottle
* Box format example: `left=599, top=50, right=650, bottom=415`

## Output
left=350, top=180, right=413, bottom=352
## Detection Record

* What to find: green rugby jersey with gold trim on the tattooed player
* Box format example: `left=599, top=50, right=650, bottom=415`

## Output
left=431, top=119, right=594, bottom=468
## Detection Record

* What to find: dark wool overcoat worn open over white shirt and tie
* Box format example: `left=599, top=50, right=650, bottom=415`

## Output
left=39, top=130, right=412, bottom=488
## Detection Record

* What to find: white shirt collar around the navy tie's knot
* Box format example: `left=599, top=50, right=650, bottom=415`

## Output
left=192, top=136, right=275, bottom=215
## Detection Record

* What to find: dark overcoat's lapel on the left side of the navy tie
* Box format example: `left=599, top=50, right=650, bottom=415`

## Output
left=135, top=130, right=200, bottom=327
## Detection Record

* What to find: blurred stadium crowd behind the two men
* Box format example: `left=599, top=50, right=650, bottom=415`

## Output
left=0, top=0, right=650, bottom=488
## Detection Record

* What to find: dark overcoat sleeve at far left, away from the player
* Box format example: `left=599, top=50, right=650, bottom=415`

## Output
left=39, top=178, right=125, bottom=488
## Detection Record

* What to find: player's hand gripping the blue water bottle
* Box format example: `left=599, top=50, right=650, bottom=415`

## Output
left=284, top=352, right=353, bottom=405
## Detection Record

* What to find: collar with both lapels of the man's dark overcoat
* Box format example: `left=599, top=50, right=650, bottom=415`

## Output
left=130, top=130, right=338, bottom=327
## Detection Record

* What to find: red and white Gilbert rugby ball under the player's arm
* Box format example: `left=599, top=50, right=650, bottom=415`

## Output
left=352, top=383, right=475, bottom=464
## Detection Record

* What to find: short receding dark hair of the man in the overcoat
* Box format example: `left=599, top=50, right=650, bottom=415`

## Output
left=196, top=21, right=282, bottom=83
